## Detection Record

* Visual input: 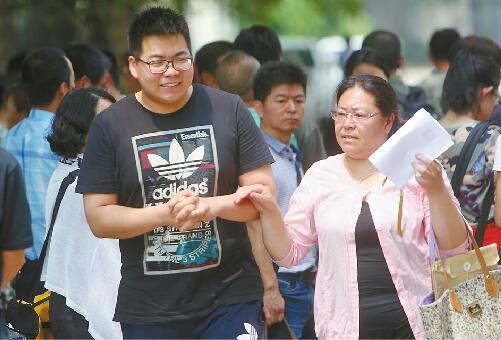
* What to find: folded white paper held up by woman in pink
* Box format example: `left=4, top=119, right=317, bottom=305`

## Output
left=369, top=109, right=453, bottom=188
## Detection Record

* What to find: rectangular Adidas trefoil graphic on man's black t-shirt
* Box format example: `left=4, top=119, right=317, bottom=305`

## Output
left=132, top=125, right=221, bottom=275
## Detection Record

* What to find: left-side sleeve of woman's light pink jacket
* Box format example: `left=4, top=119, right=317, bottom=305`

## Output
left=275, top=173, right=318, bottom=268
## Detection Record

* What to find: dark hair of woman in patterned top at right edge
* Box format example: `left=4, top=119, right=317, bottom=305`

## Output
left=442, top=52, right=500, bottom=113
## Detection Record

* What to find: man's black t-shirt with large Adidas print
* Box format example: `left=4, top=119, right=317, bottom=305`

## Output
left=76, top=85, right=273, bottom=324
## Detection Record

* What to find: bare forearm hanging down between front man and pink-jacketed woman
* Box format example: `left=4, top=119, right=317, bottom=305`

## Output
left=247, top=220, right=285, bottom=325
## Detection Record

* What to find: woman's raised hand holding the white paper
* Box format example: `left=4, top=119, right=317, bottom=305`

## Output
left=412, top=154, right=446, bottom=195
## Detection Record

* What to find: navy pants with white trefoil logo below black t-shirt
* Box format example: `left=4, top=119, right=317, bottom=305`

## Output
left=121, top=301, right=264, bottom=339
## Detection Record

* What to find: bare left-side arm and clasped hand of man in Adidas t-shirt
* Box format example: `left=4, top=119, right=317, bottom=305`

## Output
left=84, top=190, right=199, bottom=239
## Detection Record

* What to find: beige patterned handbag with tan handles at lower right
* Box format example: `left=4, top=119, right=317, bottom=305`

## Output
left=419, top=229, right=501, bottom=339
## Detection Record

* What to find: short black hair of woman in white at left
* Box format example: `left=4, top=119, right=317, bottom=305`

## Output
left=47, top=87, right=115, bottom=158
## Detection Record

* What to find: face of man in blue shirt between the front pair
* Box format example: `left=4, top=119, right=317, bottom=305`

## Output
left=256, top=84, right=305, bottom=139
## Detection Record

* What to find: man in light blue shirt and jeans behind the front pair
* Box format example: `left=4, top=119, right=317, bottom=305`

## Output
left=253, top=61, right=317, bottom=339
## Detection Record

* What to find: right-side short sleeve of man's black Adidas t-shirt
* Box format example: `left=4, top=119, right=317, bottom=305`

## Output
left=236, top=100, right=273, bottom=175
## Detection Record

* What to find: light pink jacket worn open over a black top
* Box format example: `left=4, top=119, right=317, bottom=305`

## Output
left=277, top=155, right=469, bottom=339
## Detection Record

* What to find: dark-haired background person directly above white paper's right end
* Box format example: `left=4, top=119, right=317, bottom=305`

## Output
left=421, top=28, right=461, bottom=117
